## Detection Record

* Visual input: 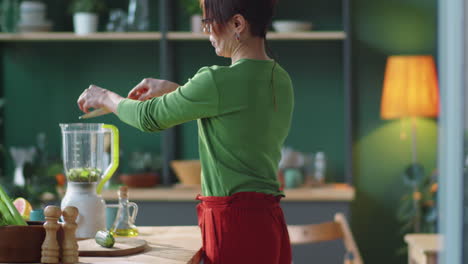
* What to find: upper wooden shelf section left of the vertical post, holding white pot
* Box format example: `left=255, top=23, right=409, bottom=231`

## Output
left=0, top=32, right=161, bottom=42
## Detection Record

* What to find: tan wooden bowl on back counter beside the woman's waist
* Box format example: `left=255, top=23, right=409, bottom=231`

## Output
left=171, top=160, right=201, bottom=185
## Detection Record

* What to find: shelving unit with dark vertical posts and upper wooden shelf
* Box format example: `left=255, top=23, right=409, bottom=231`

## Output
left=0, top=0, right=353, bottom=184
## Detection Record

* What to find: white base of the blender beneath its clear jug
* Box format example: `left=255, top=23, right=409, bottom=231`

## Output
left=60, top=182, right=106, bottom=239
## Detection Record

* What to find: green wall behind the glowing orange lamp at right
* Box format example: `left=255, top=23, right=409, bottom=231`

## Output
left=352, top=0, right=437, bottom=264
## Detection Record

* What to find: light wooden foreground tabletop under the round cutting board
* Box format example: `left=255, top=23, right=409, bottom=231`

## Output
left=80, top=226, right=202, bottom=264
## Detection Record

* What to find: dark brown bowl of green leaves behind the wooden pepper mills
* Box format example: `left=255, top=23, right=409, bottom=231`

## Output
left=0, top=221, right=63, bottom=263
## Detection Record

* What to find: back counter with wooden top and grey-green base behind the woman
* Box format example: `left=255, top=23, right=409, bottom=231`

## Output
left=102, top=184, right=355, bottom=263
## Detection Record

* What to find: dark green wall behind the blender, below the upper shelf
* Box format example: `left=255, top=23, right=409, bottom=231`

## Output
left=3, top=42, right=160, bottom=172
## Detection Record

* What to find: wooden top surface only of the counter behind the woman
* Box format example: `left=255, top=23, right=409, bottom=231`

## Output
left=102, top=184, right=354, bottom=202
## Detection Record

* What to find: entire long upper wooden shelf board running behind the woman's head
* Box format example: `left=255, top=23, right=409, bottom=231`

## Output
left=0, top=31, right=346, bottom=42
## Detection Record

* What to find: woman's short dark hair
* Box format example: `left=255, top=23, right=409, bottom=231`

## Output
left=200, top=0, right=278, bottom=38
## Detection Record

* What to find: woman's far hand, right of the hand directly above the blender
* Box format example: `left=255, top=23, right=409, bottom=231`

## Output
left=128, top=78, right=180, bottom=101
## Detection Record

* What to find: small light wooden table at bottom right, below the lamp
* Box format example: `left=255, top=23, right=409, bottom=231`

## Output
left=405, top=234, right=441, bottom=264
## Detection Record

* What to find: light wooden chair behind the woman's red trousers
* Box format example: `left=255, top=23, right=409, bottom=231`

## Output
left=288, top=213, right=363, bottom=264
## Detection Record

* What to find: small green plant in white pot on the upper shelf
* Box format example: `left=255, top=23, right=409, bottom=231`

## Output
left=70, top=0, right=106, bottom=35
